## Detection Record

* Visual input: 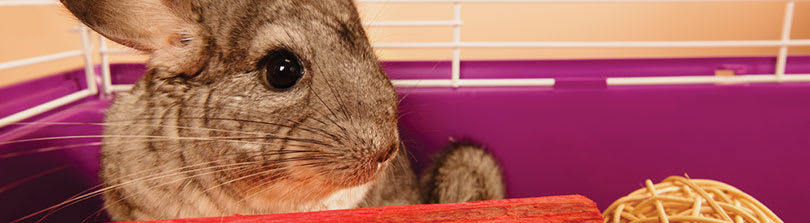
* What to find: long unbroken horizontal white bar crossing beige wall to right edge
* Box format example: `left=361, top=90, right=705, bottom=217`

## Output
left=373, top=39, right=810, bottom=48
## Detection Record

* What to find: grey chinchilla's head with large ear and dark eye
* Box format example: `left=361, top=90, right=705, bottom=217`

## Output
left=62, top=0, right=400, bottom=199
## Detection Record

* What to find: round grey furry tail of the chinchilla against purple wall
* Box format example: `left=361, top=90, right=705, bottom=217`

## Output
left=421, top=142, right=505, bottom=203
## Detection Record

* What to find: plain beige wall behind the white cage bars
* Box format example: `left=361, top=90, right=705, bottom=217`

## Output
left=0, top=2, right=810, bottom=86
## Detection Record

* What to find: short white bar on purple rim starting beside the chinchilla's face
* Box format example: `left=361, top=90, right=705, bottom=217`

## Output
left=391, top=78, right=554, bottom=87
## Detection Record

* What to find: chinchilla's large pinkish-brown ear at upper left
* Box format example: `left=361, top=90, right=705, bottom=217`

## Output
left=61, top=0, right=202, bottom=73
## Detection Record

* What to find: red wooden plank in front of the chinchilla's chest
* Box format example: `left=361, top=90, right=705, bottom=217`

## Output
left=131, top=195, right=603, bottom=223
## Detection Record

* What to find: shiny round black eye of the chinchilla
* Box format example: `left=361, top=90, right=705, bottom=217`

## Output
left=259, top=50, right=304, bottom=89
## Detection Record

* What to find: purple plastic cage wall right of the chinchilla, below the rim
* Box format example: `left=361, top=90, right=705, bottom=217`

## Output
left=400, top=84, right=810, bottom=222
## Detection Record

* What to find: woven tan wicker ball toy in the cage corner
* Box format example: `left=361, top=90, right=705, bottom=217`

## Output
left=602, top=176, right=783, bottom=223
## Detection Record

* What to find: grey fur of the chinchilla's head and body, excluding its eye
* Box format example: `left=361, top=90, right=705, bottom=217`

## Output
left=62, top=0, right=503, bottom=221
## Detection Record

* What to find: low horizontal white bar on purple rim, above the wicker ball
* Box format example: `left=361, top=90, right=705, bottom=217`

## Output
left=607, top=74, right=810, bottom=85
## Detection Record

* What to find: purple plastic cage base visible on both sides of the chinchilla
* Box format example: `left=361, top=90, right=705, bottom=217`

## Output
left=0, top=57, right=810, bottom=222
